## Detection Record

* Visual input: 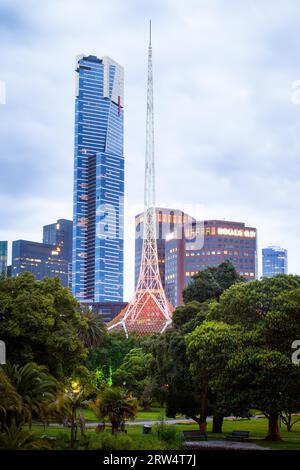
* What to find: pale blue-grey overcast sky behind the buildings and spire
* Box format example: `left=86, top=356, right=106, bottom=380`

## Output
left=0, top=0, right=300, bottom=299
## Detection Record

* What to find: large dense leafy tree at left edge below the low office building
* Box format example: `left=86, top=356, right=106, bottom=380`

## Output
left=0, top=273, right=86, bottom=378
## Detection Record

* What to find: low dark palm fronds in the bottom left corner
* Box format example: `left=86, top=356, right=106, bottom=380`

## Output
left=0, top=419, right=50, bottom=450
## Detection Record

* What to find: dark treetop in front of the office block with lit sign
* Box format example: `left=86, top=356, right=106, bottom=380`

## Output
left=183, top=261, right=244, bottom=303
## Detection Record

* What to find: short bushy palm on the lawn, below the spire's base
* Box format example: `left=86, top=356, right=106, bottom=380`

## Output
left=90, top=387, right=138, bottom=434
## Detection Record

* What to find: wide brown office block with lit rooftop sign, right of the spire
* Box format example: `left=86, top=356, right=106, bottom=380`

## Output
left=165, top=220, right=257, bottom=306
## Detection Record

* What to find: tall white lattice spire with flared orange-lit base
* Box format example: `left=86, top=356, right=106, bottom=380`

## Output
left=108, top=21, right=174, bottom=336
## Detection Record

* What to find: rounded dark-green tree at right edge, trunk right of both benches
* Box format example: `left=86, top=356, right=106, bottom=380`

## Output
left=223, top=347, right=300, bottom=441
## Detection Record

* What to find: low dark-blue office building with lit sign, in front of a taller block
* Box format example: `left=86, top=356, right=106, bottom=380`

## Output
left=12, top=240, right=68, bottom=287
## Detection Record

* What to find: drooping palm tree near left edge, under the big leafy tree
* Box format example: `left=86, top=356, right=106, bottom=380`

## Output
left=3, top=362, right=58, bottom=426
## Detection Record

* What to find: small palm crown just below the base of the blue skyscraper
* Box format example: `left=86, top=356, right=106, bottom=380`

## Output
left=78, top=307, right=106, bottom=348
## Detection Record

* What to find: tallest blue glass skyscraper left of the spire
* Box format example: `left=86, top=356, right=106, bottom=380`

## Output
left=72, top=55, right=124, bottom=302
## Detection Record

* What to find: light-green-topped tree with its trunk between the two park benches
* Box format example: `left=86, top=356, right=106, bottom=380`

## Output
left=185, top=321, right=241, bottom=430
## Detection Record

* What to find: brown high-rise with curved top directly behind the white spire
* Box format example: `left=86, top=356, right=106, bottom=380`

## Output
left=135, top=207, right=194, bottom=287
